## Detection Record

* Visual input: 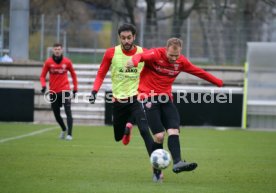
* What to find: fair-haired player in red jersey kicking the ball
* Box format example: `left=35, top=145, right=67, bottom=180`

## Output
left=126, top=38, right=223, bottom=179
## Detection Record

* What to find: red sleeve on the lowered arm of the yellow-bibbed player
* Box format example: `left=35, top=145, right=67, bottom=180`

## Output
left=92, top=48, right=115, bottom=92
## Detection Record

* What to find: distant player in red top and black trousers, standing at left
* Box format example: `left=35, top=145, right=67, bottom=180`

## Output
left=40, top=43, right=78, bottom=140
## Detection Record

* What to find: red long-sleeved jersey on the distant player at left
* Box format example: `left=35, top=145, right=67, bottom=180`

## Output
left=40, top=57, right=78, bottom=93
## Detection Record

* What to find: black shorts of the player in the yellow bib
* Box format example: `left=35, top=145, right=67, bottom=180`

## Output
left=112, top=96, right=147, bottom=141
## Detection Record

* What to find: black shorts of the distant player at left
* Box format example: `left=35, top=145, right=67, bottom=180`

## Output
left=50, top=91, right=71, bottom=107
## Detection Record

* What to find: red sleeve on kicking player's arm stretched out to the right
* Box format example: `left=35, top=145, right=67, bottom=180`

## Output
left=182, top=58, right=223, bottom=87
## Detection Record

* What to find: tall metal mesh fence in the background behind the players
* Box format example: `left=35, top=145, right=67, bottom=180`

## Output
left=0, top=14, right=276, bottom=66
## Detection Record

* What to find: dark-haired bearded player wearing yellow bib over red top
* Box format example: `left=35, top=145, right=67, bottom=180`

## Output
left=89, top=24, right=153, bottom=158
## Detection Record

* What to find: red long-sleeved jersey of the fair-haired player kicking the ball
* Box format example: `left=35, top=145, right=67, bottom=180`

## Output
left=132, top=48, right=223, bottom=99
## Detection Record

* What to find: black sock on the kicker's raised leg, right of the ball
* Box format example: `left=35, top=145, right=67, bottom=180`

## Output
left=168, top=135, right=181, bottom=164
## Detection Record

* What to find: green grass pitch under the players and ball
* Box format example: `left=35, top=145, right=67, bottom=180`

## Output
left=0, top=123, right=276, bottom=193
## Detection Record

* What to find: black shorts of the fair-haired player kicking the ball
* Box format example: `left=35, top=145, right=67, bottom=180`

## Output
left=143, top=96, right=180, bottom=134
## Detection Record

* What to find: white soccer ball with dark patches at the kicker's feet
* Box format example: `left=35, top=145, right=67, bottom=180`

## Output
left=150, top=149, right=171, bottom=170
